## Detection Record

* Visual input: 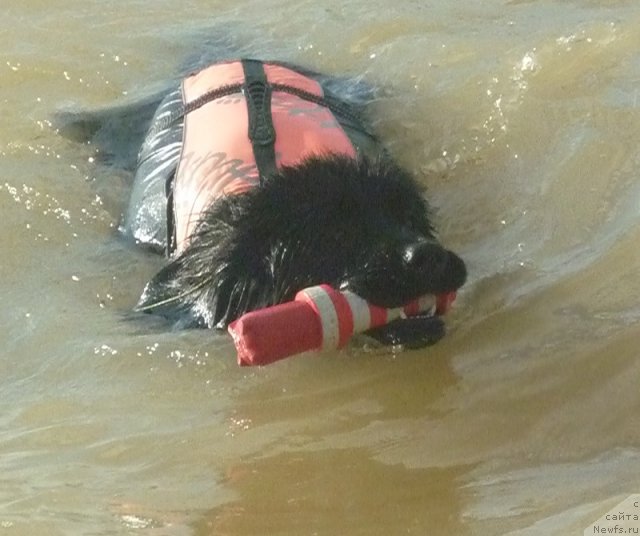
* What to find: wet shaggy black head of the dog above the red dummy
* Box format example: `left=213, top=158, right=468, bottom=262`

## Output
left=138, top=156, right=466, bottom=344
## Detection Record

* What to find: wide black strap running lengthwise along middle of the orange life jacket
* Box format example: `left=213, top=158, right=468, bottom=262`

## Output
left=242, top=59, right=276, bottom=180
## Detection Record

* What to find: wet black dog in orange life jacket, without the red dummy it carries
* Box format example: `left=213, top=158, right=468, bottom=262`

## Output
left=60, top=56, right=466, bottom=347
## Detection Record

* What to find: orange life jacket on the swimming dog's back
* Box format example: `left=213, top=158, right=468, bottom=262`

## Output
left=168, top=60, right=356, bottom=252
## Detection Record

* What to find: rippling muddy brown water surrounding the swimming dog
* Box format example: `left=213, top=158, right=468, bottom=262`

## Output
left=0, top=0, right=640, bottom=536
